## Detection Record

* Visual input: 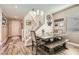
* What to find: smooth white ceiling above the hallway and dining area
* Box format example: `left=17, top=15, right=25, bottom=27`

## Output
left=0, top=4, right=74, bottom=19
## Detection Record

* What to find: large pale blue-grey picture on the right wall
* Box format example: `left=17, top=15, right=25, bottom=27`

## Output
left=67, top=17, right=79, bottom=32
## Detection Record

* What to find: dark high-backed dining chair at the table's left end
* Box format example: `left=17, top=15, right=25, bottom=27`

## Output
left=31, top=31, right=45, bottom=55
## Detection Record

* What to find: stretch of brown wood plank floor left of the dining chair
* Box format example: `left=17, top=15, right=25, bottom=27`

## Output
left=0, top=39, right=31, bottom=55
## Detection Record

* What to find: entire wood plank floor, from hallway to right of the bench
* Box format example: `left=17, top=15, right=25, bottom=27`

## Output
left=0, top=39, right=79, bottom=55
